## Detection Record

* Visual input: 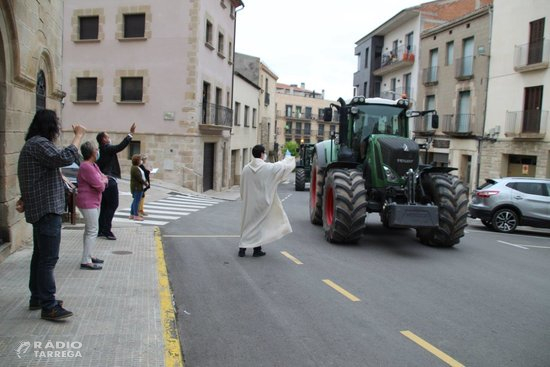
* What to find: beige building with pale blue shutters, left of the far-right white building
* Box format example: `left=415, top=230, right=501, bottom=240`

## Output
left=413, top=5, right=492, bottom=188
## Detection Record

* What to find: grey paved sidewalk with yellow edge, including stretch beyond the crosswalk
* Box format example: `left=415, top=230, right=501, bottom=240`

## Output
left=0, top=180, right=239, bottom=367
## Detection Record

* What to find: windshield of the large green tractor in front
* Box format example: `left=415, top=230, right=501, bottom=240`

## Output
left=353, top=104, right=408, bottom=140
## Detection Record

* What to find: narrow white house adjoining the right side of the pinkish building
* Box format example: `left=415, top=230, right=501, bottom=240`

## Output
left=230, top=72, right=261, bottom=185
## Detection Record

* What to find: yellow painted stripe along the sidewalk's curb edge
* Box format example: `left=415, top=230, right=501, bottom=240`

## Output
left=155, top=227, right=184, bottom=367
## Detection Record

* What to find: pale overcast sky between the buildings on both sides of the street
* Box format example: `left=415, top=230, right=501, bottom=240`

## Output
left=235, top=0, right=428, bottom=100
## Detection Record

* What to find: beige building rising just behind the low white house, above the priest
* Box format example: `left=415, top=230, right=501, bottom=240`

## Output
left=235, top=52, right=279, bottom=159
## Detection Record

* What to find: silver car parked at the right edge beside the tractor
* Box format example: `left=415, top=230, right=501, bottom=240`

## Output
left=468, top=177, right=550, bottom=233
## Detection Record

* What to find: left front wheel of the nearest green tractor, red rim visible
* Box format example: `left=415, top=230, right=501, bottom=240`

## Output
left=323, top=169, right=367, bottom=243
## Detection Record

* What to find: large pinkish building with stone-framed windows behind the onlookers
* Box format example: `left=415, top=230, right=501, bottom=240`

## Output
left=62, top=0, right=243, bottom=192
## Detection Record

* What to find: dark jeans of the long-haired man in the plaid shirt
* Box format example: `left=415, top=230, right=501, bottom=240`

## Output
left=29, top=214, right=61, bottom=310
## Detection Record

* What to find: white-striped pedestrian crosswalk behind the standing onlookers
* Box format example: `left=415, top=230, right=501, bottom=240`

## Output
left=113, top=193, right=222, bottom=226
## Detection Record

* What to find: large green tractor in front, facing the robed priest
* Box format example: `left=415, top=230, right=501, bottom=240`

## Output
left=309, top=96, right=468, bottom=247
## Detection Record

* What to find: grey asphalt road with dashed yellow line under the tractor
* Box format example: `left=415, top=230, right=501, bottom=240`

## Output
left=161, top=184, right=550, bottom=367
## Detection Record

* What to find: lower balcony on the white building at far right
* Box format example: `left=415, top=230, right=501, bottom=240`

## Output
left=504, top=110, right=548, bottom=140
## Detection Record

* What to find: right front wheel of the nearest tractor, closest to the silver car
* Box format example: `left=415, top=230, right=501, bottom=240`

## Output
left=416, top=173, right=468, bottom=247
